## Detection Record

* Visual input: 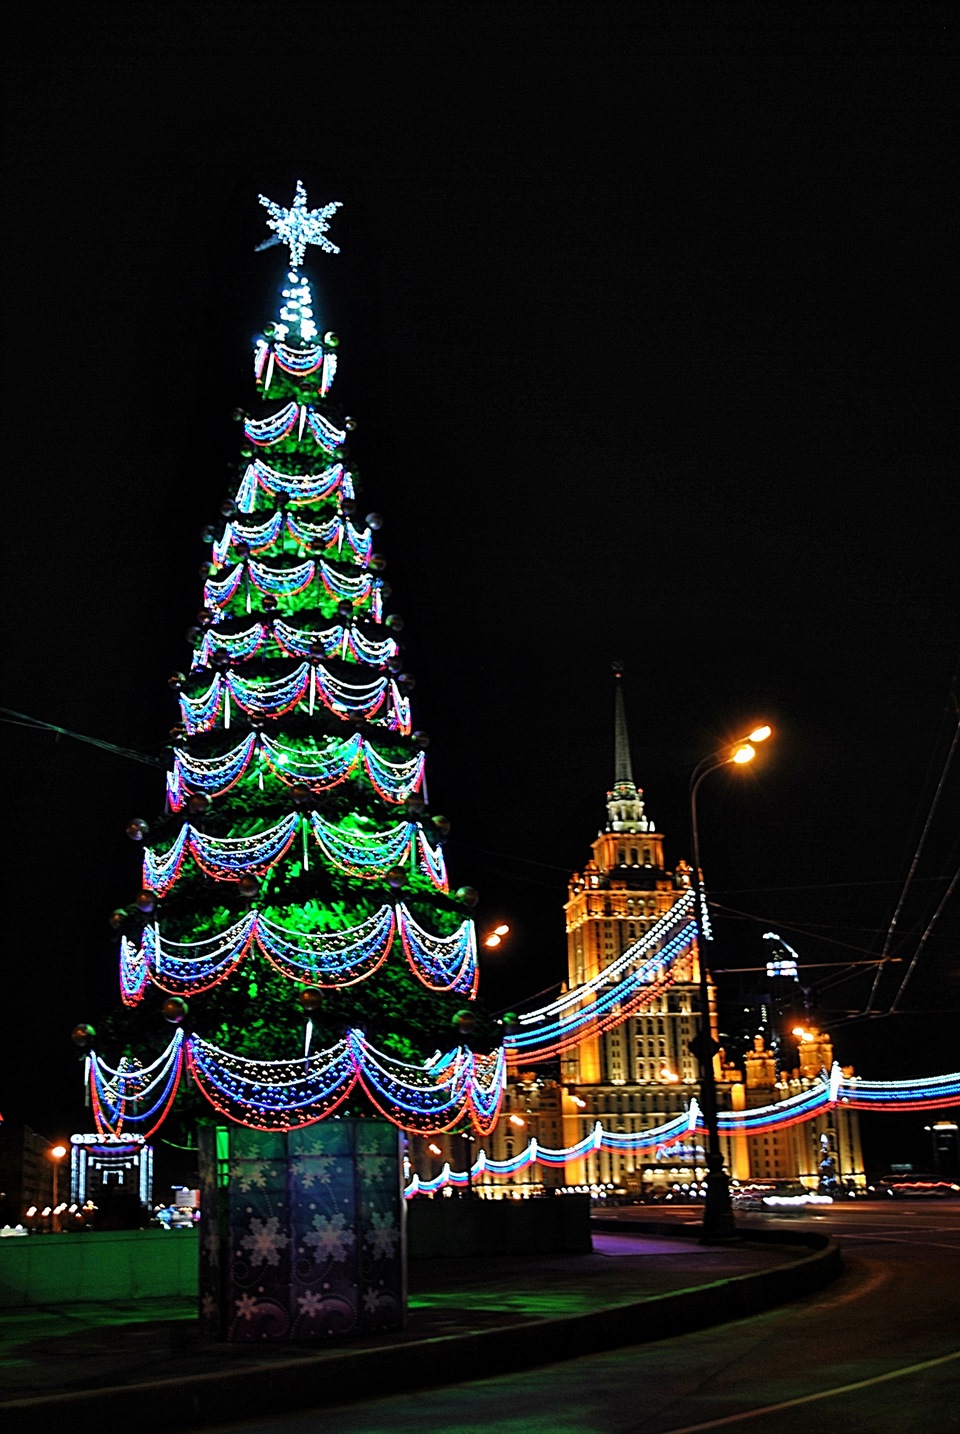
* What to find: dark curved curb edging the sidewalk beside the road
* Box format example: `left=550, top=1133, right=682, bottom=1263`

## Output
left=0, top=1220, right=842, bottom=1434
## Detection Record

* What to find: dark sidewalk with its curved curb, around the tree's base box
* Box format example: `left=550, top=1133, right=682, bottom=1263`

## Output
left=0, top=1220, right=839, bottom=1434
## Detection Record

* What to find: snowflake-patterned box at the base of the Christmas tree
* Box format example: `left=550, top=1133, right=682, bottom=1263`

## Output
left=199, top=1119, right=406, bottom=1344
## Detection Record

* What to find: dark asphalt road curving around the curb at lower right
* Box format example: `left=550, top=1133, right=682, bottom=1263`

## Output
left=195, top=1200, right=960, bottom=1434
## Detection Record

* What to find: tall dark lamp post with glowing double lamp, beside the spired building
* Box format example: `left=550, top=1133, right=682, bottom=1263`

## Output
left=690, top=726, right=771, bottom=1242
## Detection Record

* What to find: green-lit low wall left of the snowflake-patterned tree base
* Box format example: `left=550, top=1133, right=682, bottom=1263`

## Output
left=0, top=1229, right=197, bottom=1309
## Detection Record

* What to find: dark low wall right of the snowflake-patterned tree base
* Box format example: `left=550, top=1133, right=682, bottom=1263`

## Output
left=406, top=1195, right=593, bottom=1259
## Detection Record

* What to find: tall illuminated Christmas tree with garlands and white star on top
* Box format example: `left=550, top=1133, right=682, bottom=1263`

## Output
left=92, top=182, right=502, bottom=1131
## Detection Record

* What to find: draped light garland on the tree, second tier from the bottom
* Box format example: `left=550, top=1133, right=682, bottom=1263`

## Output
left=121, top=903, right=478, bottom=1007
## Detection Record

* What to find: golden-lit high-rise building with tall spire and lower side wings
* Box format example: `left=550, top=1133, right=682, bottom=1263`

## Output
left=410, top=664, right=864, bottom=1197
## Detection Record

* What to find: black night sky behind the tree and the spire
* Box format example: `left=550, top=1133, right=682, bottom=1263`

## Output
left=0, top=13, right=960, bottom=1159
